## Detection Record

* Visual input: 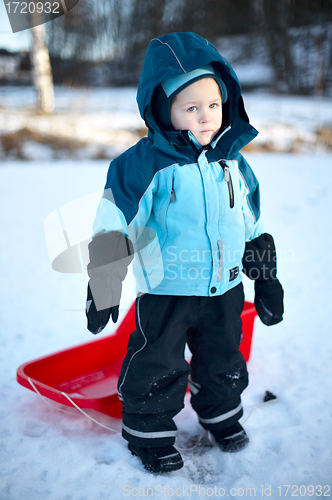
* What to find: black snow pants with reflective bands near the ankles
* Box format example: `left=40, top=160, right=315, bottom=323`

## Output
left=118, top=283, right=248, bottom=447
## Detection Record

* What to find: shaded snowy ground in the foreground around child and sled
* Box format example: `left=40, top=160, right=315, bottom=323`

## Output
left=0, top=150, right=332, bottom=500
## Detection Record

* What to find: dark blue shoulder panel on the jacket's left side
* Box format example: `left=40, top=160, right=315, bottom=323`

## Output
left=104, top=138, right=174, bottom=225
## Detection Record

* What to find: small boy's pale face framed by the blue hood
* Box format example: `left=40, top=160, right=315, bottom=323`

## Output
left=171, top=78, right=222, bottom=146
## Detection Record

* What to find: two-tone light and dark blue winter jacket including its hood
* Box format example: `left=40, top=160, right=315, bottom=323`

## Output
left=94, top=33, right=263, bottom=296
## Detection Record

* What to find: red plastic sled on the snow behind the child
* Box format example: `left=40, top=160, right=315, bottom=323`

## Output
left=17, top=302, right=257, bottom=418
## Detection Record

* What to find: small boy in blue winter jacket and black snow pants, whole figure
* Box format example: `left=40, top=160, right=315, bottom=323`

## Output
left=87, top=33, right=283, bottom=472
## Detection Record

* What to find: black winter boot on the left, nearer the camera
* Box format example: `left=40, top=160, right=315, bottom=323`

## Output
left=128, top=443, right=183, bottom=473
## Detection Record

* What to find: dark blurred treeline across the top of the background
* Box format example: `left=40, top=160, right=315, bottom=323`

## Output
left=46, top=0, right=332, bottom=93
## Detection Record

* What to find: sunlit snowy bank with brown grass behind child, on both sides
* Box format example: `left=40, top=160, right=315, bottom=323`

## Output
left=0, top=84, right=332, bottom=160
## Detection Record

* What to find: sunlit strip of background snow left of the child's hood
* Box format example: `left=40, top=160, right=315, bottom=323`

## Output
left=0, top=86, right=144, bottom=160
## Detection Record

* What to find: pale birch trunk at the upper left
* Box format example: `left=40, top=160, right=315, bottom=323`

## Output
left=31, top=20, right=54, bottom=113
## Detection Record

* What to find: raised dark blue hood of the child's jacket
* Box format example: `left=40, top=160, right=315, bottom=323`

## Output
left=137, top=32, right=258, bottom=155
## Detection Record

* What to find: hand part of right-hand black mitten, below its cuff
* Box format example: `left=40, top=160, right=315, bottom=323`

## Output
left=255, top=278, right=284, bottom=326
